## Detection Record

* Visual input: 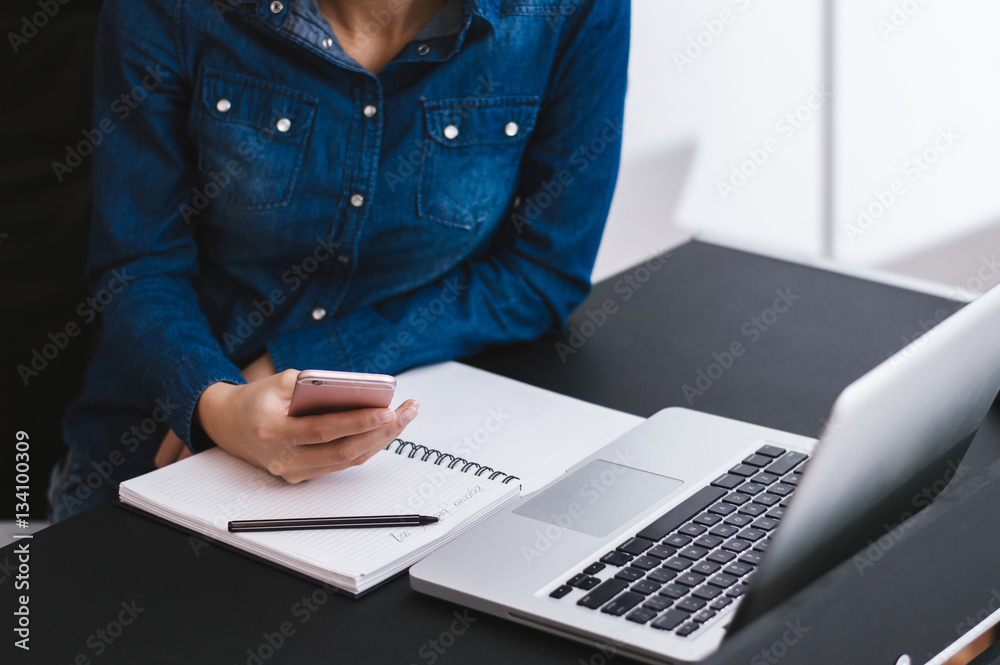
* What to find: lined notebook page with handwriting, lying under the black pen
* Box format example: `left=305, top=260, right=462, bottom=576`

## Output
left=121, top=448, right=516, bottom=591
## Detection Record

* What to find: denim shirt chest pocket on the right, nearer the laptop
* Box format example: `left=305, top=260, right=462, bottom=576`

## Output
left=417, top=96, right=538, bottom=229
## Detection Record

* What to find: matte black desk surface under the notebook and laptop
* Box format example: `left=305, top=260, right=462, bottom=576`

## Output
left=0, top=242, right=1000, bottom=665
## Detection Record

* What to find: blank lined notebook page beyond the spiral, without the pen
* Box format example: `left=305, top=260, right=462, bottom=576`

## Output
left=393, top=362, right=643, bottom=494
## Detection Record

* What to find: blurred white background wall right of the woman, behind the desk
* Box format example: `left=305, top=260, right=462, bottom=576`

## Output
left=594, top=0, right=1000, bottom=292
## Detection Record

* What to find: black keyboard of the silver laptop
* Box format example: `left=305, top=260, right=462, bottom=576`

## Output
left=549, top=445, right=808, bottom=637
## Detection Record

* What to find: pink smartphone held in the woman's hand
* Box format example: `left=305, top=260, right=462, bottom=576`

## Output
left=288, top=369, right=396, bottom=416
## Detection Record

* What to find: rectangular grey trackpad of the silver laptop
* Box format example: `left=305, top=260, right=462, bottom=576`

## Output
left=514, top=460, right=684, bottom=537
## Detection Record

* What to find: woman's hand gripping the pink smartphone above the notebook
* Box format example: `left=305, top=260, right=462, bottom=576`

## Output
left=195, top=369, right=419, bottom=483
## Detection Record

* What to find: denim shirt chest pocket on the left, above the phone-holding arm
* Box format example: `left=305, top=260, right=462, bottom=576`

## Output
left=198, top=69, right=319, bottom=209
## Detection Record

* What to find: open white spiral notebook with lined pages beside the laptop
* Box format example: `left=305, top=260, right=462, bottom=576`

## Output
left=119, top=363, right=641, bottom=596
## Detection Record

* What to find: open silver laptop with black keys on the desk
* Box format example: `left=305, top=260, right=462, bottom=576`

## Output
left=410, top=288, right=1000, bottom=663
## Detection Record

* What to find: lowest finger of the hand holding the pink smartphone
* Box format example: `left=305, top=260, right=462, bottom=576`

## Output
left=282, top=400, right=420, bottom=482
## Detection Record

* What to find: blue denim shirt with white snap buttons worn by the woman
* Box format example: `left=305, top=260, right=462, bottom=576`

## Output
left=65, top=0, right=629, bottom=483
